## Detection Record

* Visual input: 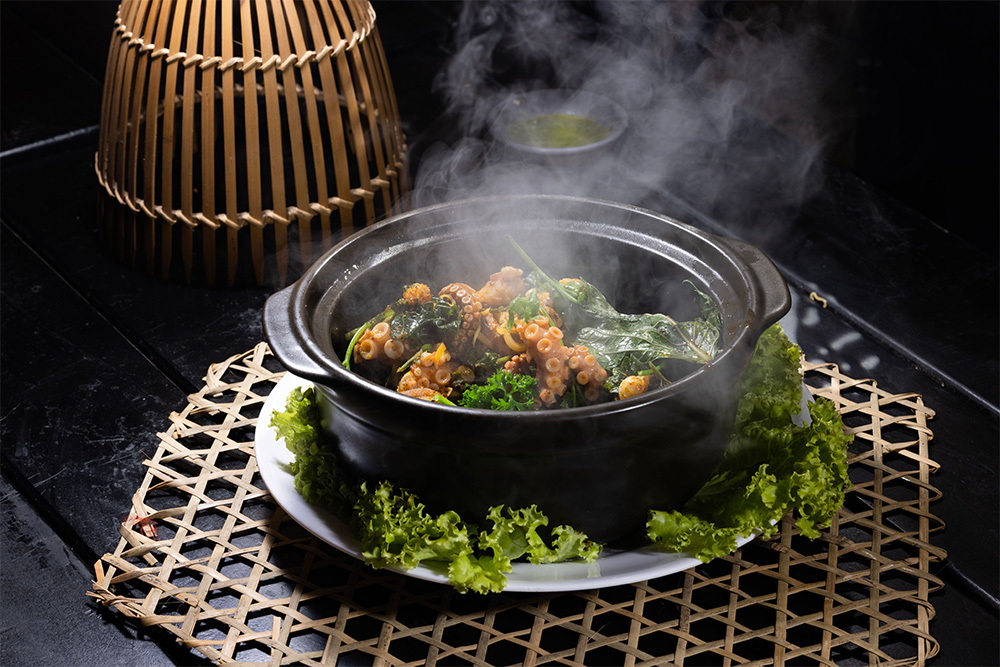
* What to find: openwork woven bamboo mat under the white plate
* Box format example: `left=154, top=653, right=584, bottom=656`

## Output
left=90, top=343, right=945, bottom=665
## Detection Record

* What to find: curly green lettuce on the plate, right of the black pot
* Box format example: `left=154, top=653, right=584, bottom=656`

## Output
left=646, top=325, right=853, bottom=562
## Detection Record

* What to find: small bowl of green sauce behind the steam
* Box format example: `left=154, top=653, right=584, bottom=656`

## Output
left=492, top=89, right=628, bottom=157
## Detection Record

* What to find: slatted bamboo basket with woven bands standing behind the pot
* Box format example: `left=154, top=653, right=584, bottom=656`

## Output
left=95, top=0, right=409, bottom=285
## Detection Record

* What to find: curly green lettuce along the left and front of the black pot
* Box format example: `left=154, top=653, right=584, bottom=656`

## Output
left=270, top=388, right=601, bottom=593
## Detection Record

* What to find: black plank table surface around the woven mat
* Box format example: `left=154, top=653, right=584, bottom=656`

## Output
left=0, top=2, right=1000, bottom=665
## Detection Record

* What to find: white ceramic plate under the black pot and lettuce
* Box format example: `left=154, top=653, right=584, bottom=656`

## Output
left=254, top=373, right=753, bottom=593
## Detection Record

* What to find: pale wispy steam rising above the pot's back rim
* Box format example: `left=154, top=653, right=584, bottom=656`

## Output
left=402, top=0, right=853, bottom=235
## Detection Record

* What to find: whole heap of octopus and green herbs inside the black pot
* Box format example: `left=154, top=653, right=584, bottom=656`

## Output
left=344, top=237, right=719, bottom=410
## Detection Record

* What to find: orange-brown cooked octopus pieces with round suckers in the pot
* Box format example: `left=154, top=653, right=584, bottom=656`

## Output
left=340, top=266, right=700, bottom=409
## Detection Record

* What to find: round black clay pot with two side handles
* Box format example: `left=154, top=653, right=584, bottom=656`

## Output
left=264, top=196, right=790, bottom=541
